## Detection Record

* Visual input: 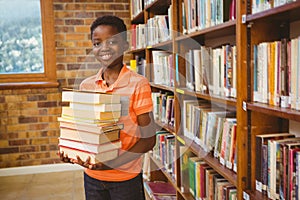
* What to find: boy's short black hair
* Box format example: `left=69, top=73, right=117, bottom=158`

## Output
left=90, top=15, right=127, bottom=41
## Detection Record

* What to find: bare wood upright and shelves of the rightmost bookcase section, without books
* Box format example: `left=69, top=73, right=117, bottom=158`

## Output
left=237, top=1, right=300, bottom=199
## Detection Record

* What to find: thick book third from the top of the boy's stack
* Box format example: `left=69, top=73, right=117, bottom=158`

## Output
left=62, top=106, right=121, bottom=120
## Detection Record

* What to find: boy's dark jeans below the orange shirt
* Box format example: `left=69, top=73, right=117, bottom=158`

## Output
left=84, top=173, right=145, bottom=200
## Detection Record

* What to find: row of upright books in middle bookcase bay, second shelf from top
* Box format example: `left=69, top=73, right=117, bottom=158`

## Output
left=185, top=45, right=237, bottom=97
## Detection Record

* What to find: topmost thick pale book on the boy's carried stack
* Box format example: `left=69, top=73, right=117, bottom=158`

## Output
left=62, top=89, right=121, bottom=104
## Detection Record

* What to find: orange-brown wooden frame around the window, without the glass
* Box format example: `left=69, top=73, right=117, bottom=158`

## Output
left=0, top=0, right=58, bottom=89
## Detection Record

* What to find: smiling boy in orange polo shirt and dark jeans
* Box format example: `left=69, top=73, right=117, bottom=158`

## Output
left=60, top=16, right=155, bottom=200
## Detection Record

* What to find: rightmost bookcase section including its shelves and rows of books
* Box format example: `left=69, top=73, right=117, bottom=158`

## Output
left=238, top=1, right=300, bottom=199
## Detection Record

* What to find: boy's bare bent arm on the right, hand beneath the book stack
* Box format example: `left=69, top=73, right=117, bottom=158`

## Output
left=73, top=112, right=156, bottom=170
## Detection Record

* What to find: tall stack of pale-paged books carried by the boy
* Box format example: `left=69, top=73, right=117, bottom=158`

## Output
left=58, top=90, right=123, bottom=163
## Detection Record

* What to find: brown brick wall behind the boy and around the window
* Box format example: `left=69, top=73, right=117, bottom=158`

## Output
left=0, top=0, right=130, bottom=168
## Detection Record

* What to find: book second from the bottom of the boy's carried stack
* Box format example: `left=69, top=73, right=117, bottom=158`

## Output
left=59, top=138, right=121, bottom=153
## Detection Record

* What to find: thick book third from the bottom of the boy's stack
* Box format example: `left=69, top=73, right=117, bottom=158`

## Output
left=60, top=127, right=120, bottom=144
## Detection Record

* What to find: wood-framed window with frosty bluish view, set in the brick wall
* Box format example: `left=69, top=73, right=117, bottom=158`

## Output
left=0, top=0, right=57, bottom=88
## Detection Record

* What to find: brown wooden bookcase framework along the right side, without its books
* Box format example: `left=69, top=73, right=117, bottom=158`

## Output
left=128, top=0, right=300, bottom=200
